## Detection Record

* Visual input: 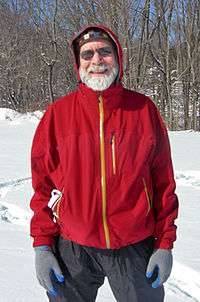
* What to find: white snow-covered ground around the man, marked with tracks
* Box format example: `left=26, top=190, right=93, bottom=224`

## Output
left=0, top=108, right=200, bottom=302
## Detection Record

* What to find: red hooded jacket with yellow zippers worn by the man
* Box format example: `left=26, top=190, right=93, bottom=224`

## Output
left=31, top=26, right=178, bottom=249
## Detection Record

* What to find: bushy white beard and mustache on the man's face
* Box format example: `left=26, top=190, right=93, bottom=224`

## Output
left=79, top=64, right=119, bottom=91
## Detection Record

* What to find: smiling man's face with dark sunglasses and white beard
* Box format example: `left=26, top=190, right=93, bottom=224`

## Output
left=79, top=40, right=118, bottom=91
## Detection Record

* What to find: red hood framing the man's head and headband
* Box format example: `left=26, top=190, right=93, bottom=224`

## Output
left=71, top=24, right=123, bottom=81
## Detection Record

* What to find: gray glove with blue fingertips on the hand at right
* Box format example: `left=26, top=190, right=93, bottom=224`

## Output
left=146, top=249, right=173, bottom=288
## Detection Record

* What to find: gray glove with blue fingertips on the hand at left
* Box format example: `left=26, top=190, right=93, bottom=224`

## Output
left=34, top=245, right=64, bottom=296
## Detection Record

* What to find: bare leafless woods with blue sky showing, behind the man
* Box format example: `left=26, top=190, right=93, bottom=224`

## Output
left=0, top=0, right=200, bottom=131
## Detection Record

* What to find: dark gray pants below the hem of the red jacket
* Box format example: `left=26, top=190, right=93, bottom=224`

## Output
left=48, top=237, right=164, bottom=302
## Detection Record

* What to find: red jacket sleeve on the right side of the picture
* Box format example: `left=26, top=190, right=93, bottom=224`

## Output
left=151, top=102, right=178, bottom=249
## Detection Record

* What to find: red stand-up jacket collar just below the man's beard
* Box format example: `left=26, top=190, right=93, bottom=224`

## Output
left=78, top=83, right=123, bottom=110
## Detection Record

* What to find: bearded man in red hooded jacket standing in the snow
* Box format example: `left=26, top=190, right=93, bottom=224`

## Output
left=31, top=25, right=178, bottom=302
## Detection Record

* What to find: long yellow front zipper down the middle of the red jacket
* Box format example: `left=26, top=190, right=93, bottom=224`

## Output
left=99, top=95, right=110, bottom=249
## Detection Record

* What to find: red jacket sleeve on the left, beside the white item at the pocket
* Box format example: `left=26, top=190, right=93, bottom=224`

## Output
left=30, top=106, right=59, bottom=246
